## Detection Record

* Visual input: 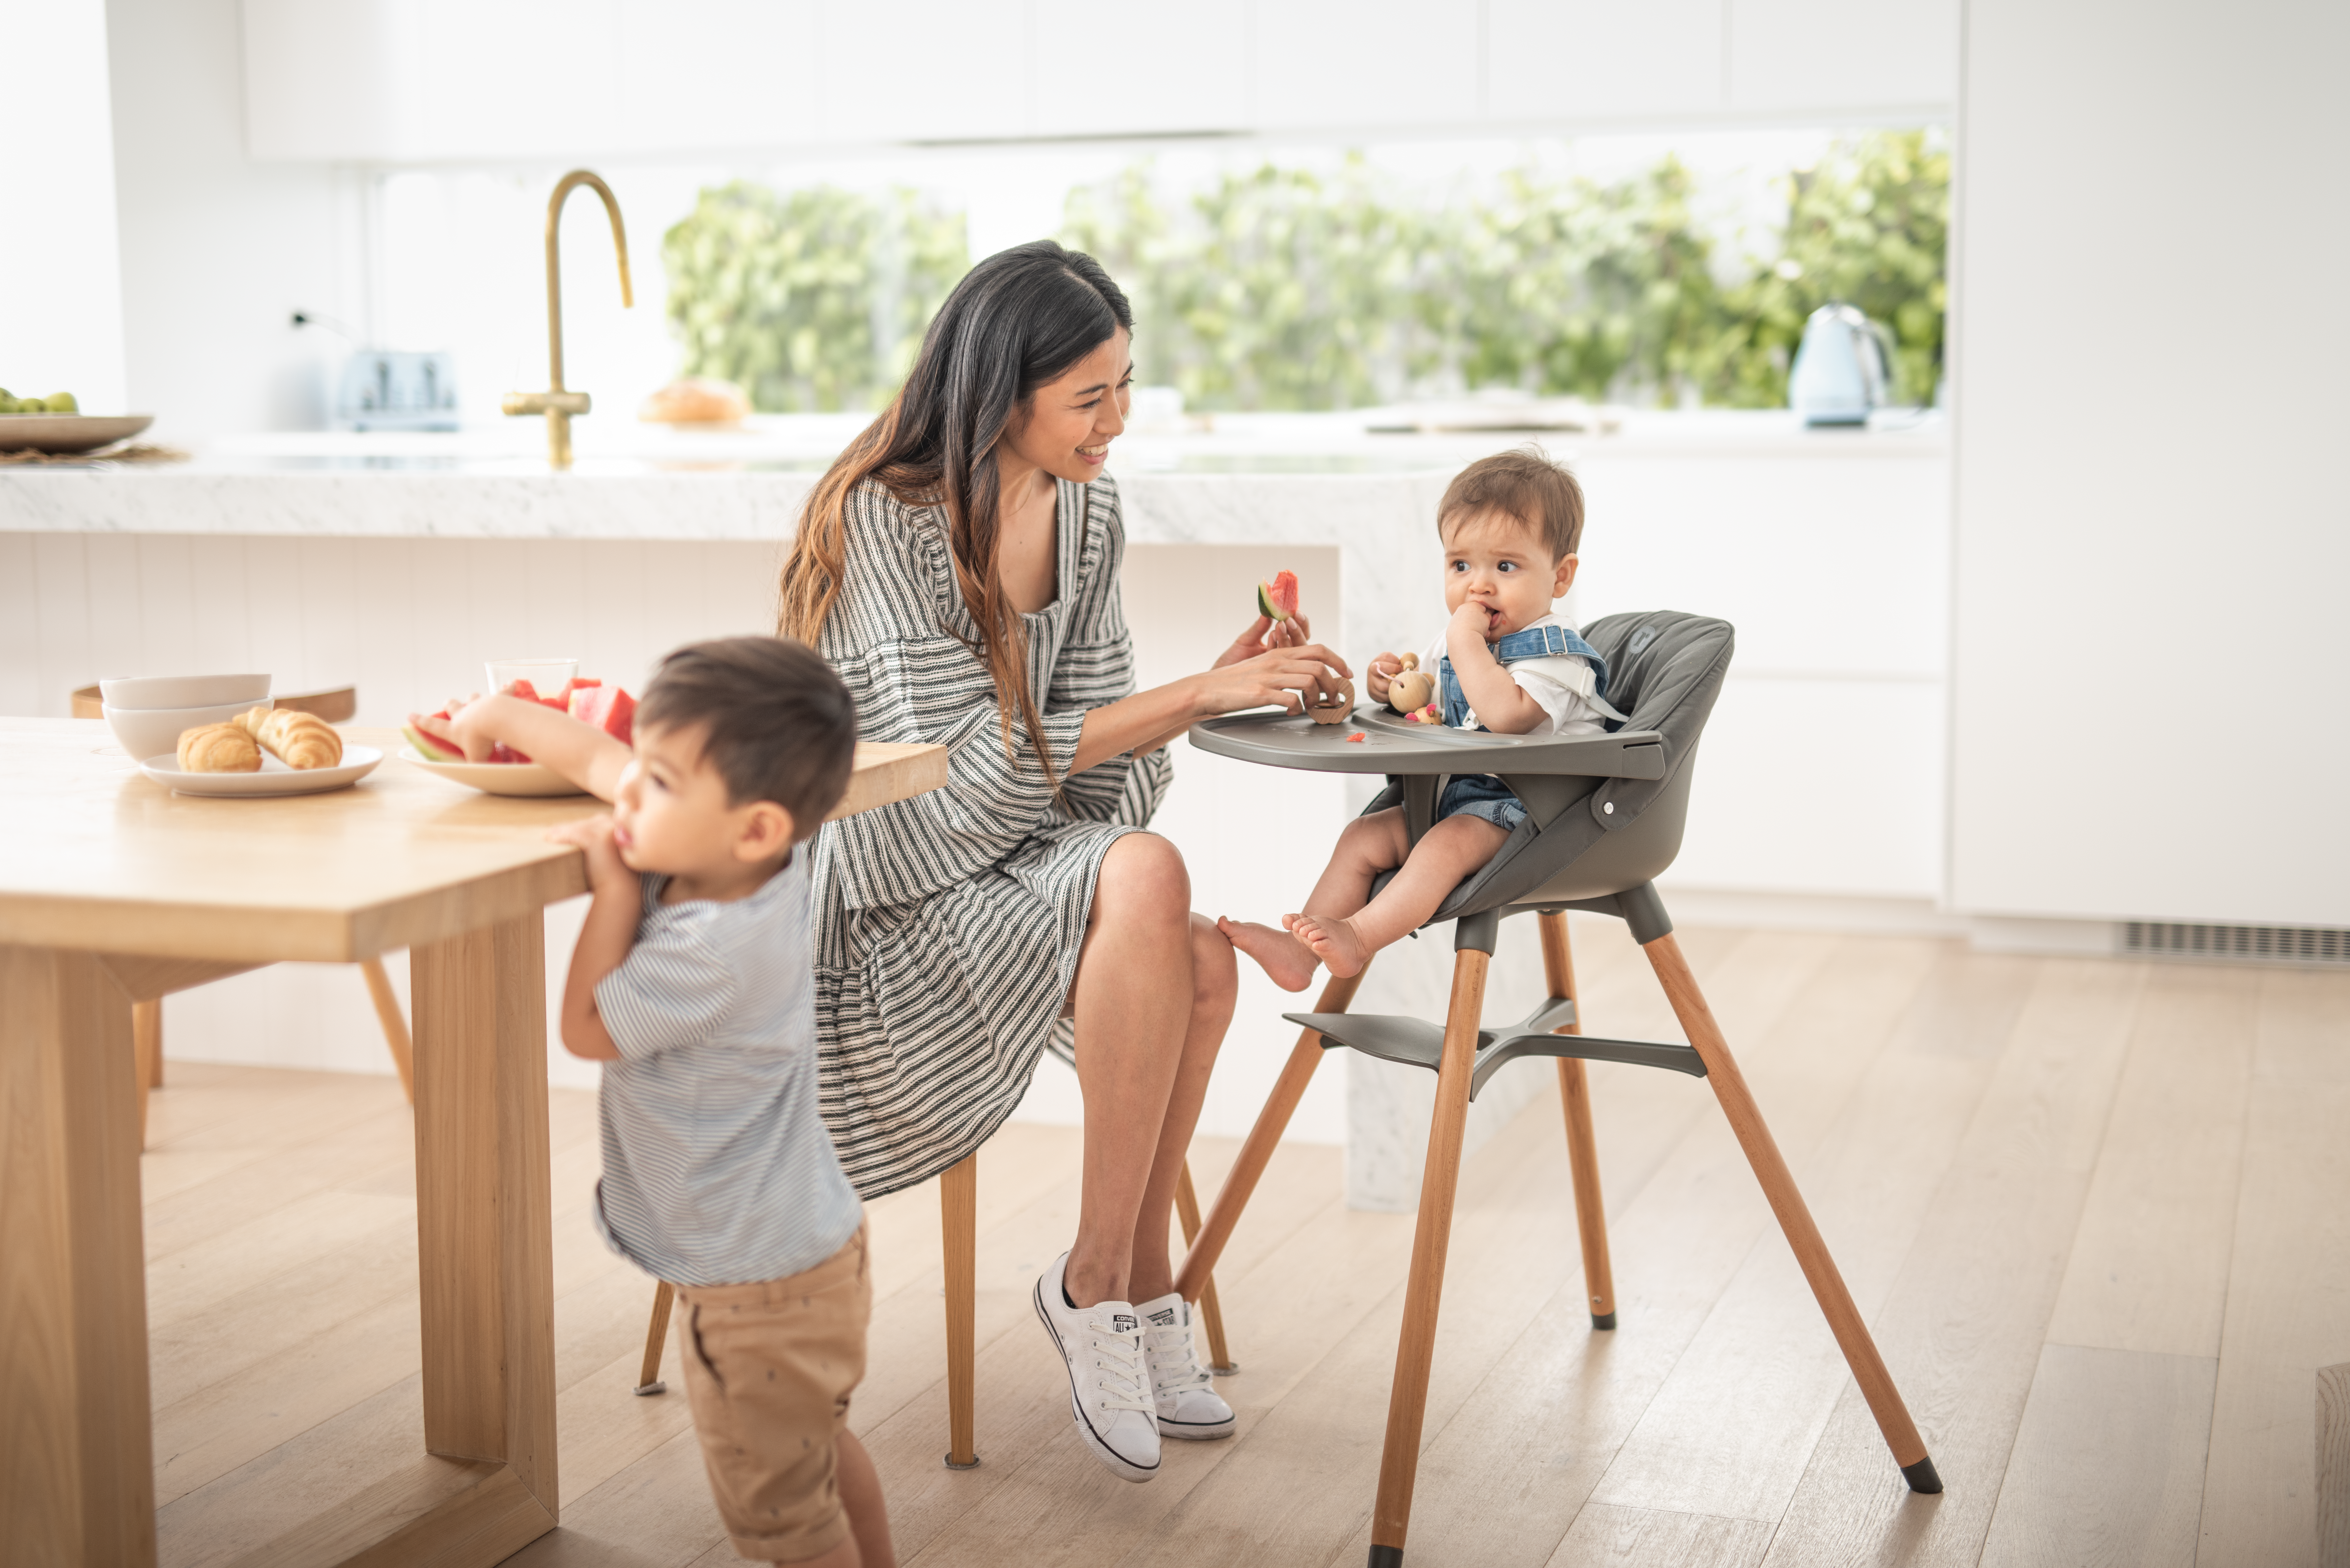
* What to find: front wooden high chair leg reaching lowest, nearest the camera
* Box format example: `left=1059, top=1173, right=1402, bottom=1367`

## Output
left=1370, top=940, right=1492, bottom=1568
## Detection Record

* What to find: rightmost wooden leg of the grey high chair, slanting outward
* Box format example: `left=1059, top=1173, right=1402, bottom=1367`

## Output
left=1645, top=933, right=1941, bottom=1493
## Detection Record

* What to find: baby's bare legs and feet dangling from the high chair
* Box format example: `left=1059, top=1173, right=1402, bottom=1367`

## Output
left=1215, top=806, right=1509, bottom=992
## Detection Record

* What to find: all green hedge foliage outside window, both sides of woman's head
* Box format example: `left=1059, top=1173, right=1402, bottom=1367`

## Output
left=663, top=132, right=1951, bottom=411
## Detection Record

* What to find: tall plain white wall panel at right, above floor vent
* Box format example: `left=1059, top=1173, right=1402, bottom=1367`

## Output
left=1951, top=0, right=2350, bottom=924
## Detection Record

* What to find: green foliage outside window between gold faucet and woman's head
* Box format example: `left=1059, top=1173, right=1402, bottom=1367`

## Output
left=660, top=181, right=971, bottom=414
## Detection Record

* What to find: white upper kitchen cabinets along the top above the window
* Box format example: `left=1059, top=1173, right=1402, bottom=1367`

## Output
left=244, top=0, right=1958, bottom=162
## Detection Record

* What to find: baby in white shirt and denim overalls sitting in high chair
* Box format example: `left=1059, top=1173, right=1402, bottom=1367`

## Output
left=1215, top=451, right=1624, bottom=992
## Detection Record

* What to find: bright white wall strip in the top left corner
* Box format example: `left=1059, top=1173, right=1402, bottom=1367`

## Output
left=0, top=0, right=125, bottom=414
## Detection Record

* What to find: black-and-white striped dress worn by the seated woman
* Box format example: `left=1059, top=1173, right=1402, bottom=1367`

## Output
left=813, top=477, right=1170, bottom=1199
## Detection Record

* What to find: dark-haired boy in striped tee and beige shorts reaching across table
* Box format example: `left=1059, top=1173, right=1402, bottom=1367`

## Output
left=413, top=637, right=895, bottom=1568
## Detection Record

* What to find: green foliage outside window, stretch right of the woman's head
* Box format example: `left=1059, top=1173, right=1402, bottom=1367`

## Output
left=1062, top=132, right=1951, bottom=409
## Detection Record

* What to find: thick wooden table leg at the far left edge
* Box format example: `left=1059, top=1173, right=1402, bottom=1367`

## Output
left=0, top=947, right=155, bottom=1568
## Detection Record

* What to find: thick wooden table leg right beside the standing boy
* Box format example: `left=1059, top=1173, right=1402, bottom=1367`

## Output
left=409, top=912, right=557, bottom=1561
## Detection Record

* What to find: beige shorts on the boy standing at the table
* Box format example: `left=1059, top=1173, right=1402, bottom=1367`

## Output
left=677, top=1225, right=874, bottom=1563
